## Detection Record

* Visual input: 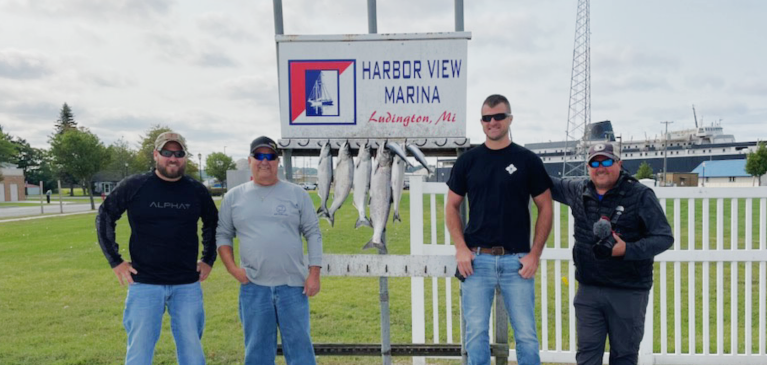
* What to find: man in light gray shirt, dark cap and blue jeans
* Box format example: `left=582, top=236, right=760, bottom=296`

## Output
left=216, top=137, right=322, bottom=365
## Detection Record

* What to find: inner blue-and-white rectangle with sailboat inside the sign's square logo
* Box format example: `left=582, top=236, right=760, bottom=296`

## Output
left=306, top=70, right=339, bottom=117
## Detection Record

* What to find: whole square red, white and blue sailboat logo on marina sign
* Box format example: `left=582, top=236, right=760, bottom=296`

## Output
left=288, top=60, right=357, bottom=125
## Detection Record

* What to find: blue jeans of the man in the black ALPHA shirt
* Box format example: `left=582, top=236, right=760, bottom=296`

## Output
left=123, top=282, right=205, bottom=365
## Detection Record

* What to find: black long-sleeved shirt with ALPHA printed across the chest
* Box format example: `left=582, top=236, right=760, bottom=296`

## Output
left=96, top=172, right=218, bottom=285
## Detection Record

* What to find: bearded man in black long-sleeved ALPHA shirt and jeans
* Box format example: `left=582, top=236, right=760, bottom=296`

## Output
left=96, top=132, right=218, bottom=364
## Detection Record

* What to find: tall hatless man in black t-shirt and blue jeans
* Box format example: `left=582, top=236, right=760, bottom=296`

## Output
left=445, top=95, right=552, bottom=365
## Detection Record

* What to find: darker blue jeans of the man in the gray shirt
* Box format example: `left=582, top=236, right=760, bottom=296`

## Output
left=240, top=283, right=316, bottom=365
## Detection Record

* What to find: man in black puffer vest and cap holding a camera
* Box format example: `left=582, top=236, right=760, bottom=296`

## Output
left=551, top=143, right=674, bottom=365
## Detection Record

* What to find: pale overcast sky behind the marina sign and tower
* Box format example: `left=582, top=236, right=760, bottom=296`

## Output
left=0, top=0, right=767, bottom=165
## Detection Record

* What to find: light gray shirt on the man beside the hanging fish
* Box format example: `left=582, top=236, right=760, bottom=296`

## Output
left=216, top=180, right=322, bottom=286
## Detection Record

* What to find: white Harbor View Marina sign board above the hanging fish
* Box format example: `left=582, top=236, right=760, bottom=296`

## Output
left=277, top=33, right=471, bottom=138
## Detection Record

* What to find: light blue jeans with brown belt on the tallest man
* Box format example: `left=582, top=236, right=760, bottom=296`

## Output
left=461, top=254, right=541, bottom=365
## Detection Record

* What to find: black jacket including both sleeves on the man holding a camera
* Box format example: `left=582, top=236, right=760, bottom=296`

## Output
left=551, top=172, right=674, bottom=289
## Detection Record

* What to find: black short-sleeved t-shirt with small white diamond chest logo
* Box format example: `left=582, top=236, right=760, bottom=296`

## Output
left=447, top=143, right=551, bottom=253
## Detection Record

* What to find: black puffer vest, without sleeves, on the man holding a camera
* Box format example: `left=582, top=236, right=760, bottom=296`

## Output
left=572, top=172, right=653, bottom=289
